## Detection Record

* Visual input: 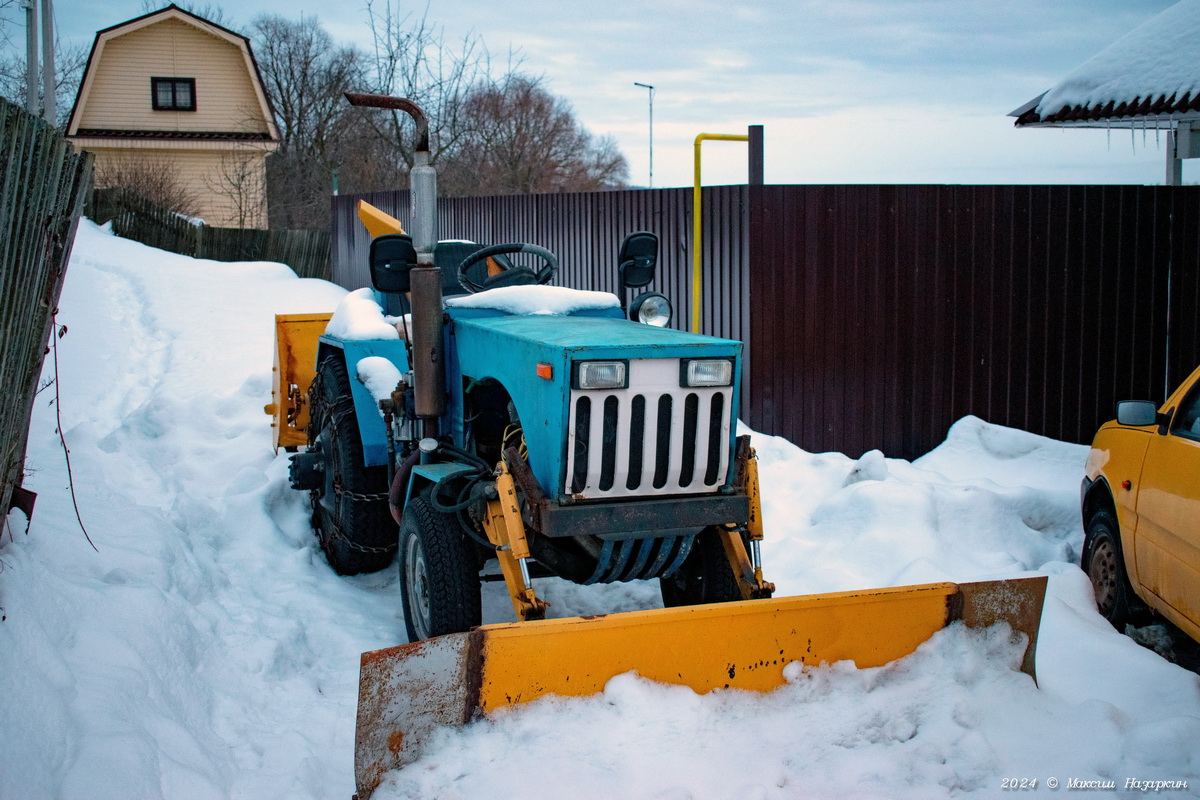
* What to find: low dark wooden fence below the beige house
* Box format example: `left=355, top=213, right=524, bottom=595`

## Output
left=88, top=188, right=330, bottom=281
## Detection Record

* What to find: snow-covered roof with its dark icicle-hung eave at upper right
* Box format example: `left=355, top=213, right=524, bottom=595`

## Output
left=1009, top=0, right=1200, bottom=127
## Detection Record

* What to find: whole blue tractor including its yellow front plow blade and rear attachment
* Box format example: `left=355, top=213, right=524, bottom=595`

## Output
left=268, top=95, right=1046, bottom=799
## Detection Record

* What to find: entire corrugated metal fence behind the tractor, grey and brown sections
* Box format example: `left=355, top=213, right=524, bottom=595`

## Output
left=334, top=186, right=1200, bottom=458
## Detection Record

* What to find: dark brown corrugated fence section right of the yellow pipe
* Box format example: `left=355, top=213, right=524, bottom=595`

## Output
left=748, top=186, right=1200, bottom=458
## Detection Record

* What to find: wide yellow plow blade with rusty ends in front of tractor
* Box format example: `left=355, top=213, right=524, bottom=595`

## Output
left=354, top=577, right=1046, bottom=800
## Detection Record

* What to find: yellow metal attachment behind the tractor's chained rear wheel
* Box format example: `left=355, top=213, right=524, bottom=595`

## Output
left=263, top=314, right=332, bottom=450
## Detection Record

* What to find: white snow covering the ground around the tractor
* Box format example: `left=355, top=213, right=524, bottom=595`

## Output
left=7, top=222, right=1200, bottom=800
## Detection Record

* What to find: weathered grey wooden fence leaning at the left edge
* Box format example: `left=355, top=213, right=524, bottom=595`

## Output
left=0, top=98, right=91, bottom=513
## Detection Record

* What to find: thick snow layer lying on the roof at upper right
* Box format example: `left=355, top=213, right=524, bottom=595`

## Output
left=1037, top=0, right=1200, bottom=116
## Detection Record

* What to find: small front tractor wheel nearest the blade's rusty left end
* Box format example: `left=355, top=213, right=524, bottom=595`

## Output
left=400, top=495, right=484, bottom=642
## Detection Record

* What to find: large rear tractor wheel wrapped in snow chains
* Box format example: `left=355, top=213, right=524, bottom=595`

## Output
left=308, top=354, right=396, bottom=575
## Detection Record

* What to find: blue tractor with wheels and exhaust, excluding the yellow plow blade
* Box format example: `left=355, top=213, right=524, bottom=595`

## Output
left=277, top=95, right=773, bottom=642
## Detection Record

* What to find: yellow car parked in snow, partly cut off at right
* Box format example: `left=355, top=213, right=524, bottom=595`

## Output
left=1082, top=368, right=1200, bottom=642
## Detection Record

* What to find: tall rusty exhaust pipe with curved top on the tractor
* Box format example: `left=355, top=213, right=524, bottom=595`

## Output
left=346, top=92, right=446, bottom=429
